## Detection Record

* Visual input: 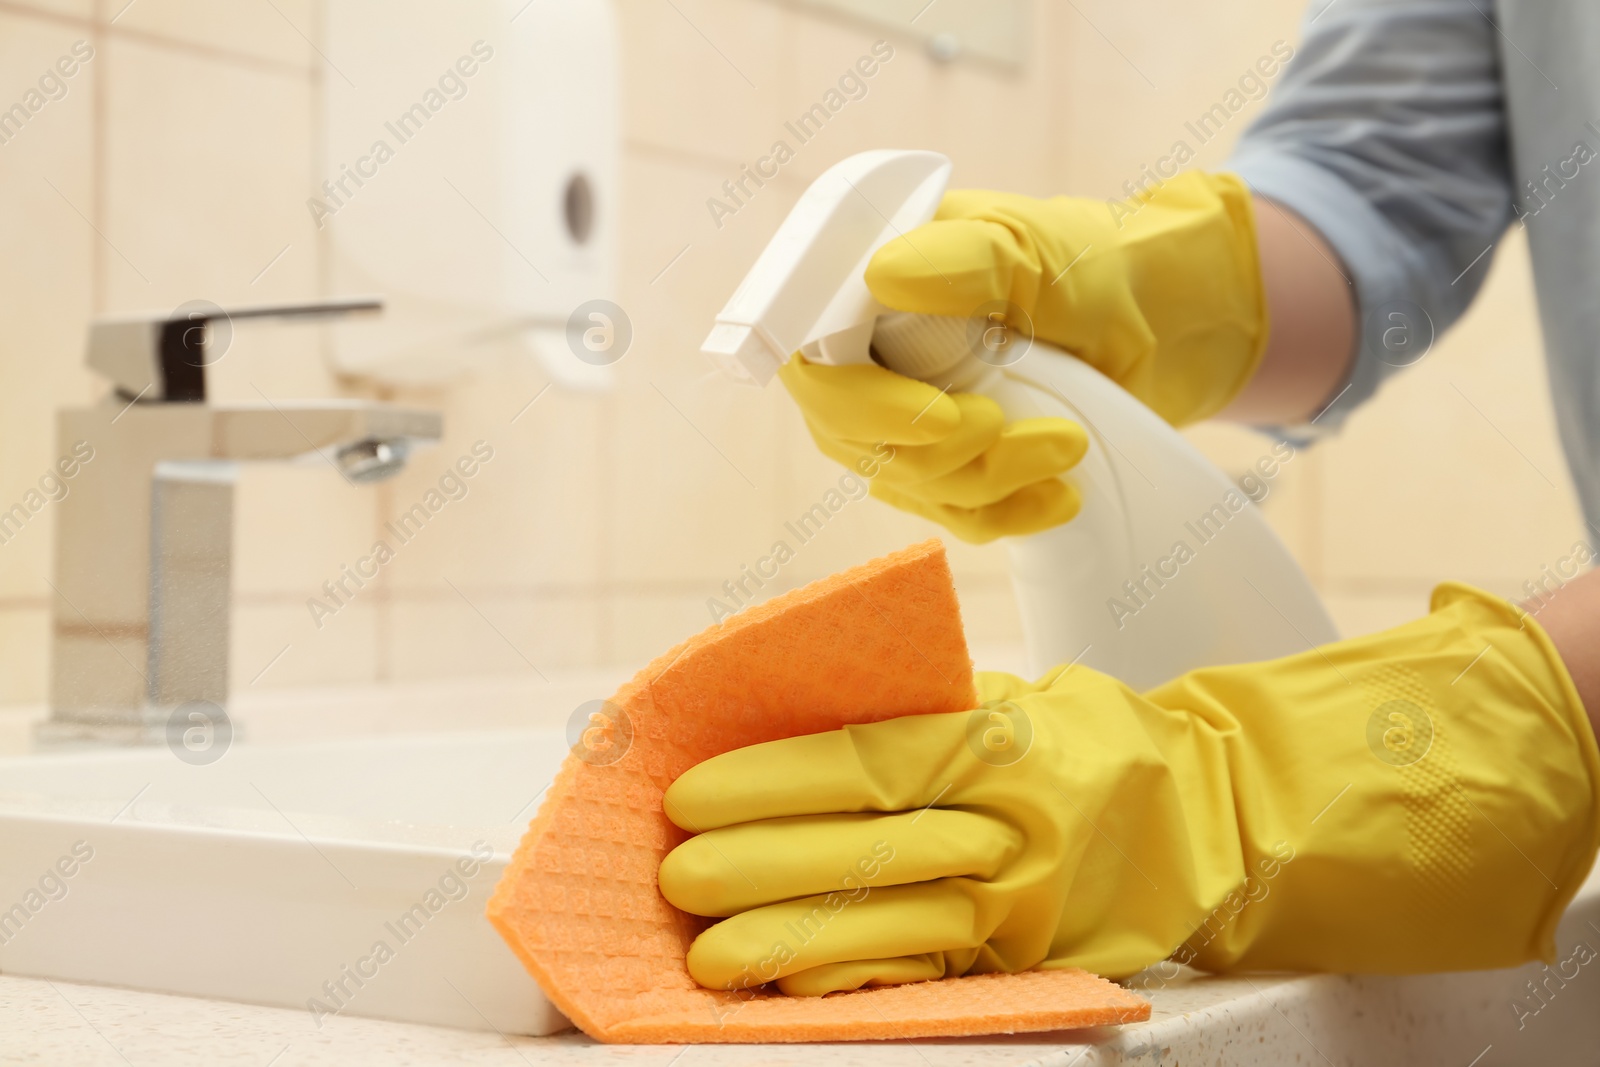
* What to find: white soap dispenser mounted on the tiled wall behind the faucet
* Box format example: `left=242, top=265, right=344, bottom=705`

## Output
left=318, top=0, right=617, bottom=390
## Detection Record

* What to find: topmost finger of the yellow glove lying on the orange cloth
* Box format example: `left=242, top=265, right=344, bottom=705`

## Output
left=662, top=712, right=966, bottom=831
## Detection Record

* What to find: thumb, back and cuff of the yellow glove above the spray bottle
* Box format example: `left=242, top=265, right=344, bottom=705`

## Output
left=866, top=171, right=1267, bottom=426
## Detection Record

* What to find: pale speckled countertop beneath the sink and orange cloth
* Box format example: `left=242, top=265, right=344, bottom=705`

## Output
left=9, top=915, right=1600, bottom=1067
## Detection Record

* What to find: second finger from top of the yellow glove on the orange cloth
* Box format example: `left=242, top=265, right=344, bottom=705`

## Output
left=659, top=808, right=1022, bottom=917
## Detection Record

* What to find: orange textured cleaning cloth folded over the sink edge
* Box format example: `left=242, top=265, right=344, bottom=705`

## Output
left=488, top=541, right=1150, bottom=1043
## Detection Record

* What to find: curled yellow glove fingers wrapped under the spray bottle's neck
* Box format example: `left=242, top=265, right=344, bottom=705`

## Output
left=779, top=355, right=1088, bottom=542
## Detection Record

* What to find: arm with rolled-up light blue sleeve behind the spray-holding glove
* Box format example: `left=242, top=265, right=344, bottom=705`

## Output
left=1224, top=0, right=1512, bottom=435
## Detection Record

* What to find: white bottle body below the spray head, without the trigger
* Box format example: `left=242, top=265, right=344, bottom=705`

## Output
left=874, top=329, right=1338, bottom=688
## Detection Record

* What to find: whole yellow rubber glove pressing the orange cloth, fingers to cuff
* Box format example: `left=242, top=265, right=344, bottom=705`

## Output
left=659, top=585, right=1600, bottom=995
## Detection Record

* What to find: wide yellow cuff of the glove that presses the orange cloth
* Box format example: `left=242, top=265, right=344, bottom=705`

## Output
left=1184, top=584, right=1600, bottom=974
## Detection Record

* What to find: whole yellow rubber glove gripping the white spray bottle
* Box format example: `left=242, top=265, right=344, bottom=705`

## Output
left=779, top=173, right=1267, bottom=542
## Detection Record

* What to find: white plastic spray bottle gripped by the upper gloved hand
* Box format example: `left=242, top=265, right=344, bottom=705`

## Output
left=702, top=150, right=1338, bottom=688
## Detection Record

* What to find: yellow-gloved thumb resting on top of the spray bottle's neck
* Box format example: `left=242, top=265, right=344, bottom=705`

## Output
left=866, top=219, right=1040, bottom=318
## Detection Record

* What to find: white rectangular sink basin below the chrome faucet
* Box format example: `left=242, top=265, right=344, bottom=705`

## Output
left=0, top=729, right=568, bottom=1035
